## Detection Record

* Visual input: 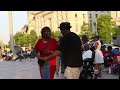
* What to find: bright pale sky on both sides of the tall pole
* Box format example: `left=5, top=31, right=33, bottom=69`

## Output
left=0, top=11, right=27, bottom=43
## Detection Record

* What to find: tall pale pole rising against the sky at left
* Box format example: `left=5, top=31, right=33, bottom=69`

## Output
left=8, top=11, right=14, bottom=53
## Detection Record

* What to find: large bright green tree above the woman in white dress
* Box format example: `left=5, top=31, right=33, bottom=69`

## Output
left=97, top=14, right=115, bottom=43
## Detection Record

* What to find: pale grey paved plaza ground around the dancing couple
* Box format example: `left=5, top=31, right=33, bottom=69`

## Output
left=0, top=60, right=118, bottom=79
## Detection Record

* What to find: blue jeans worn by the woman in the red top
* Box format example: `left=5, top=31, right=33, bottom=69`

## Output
left=41, top=62, right=50, bottom=79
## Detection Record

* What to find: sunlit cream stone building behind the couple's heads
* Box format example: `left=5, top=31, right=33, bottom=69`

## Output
left=27, top=11, right=88, bottom=35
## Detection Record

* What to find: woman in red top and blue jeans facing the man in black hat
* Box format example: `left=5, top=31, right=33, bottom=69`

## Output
left=35, top=27, right=58, bottom=79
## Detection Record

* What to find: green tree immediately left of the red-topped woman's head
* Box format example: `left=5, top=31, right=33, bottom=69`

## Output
left=29, top=30, right=38, bottom=47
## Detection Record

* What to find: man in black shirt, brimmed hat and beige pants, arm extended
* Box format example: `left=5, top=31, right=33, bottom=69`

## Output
left=43, top=22, right=83, bottom=79
